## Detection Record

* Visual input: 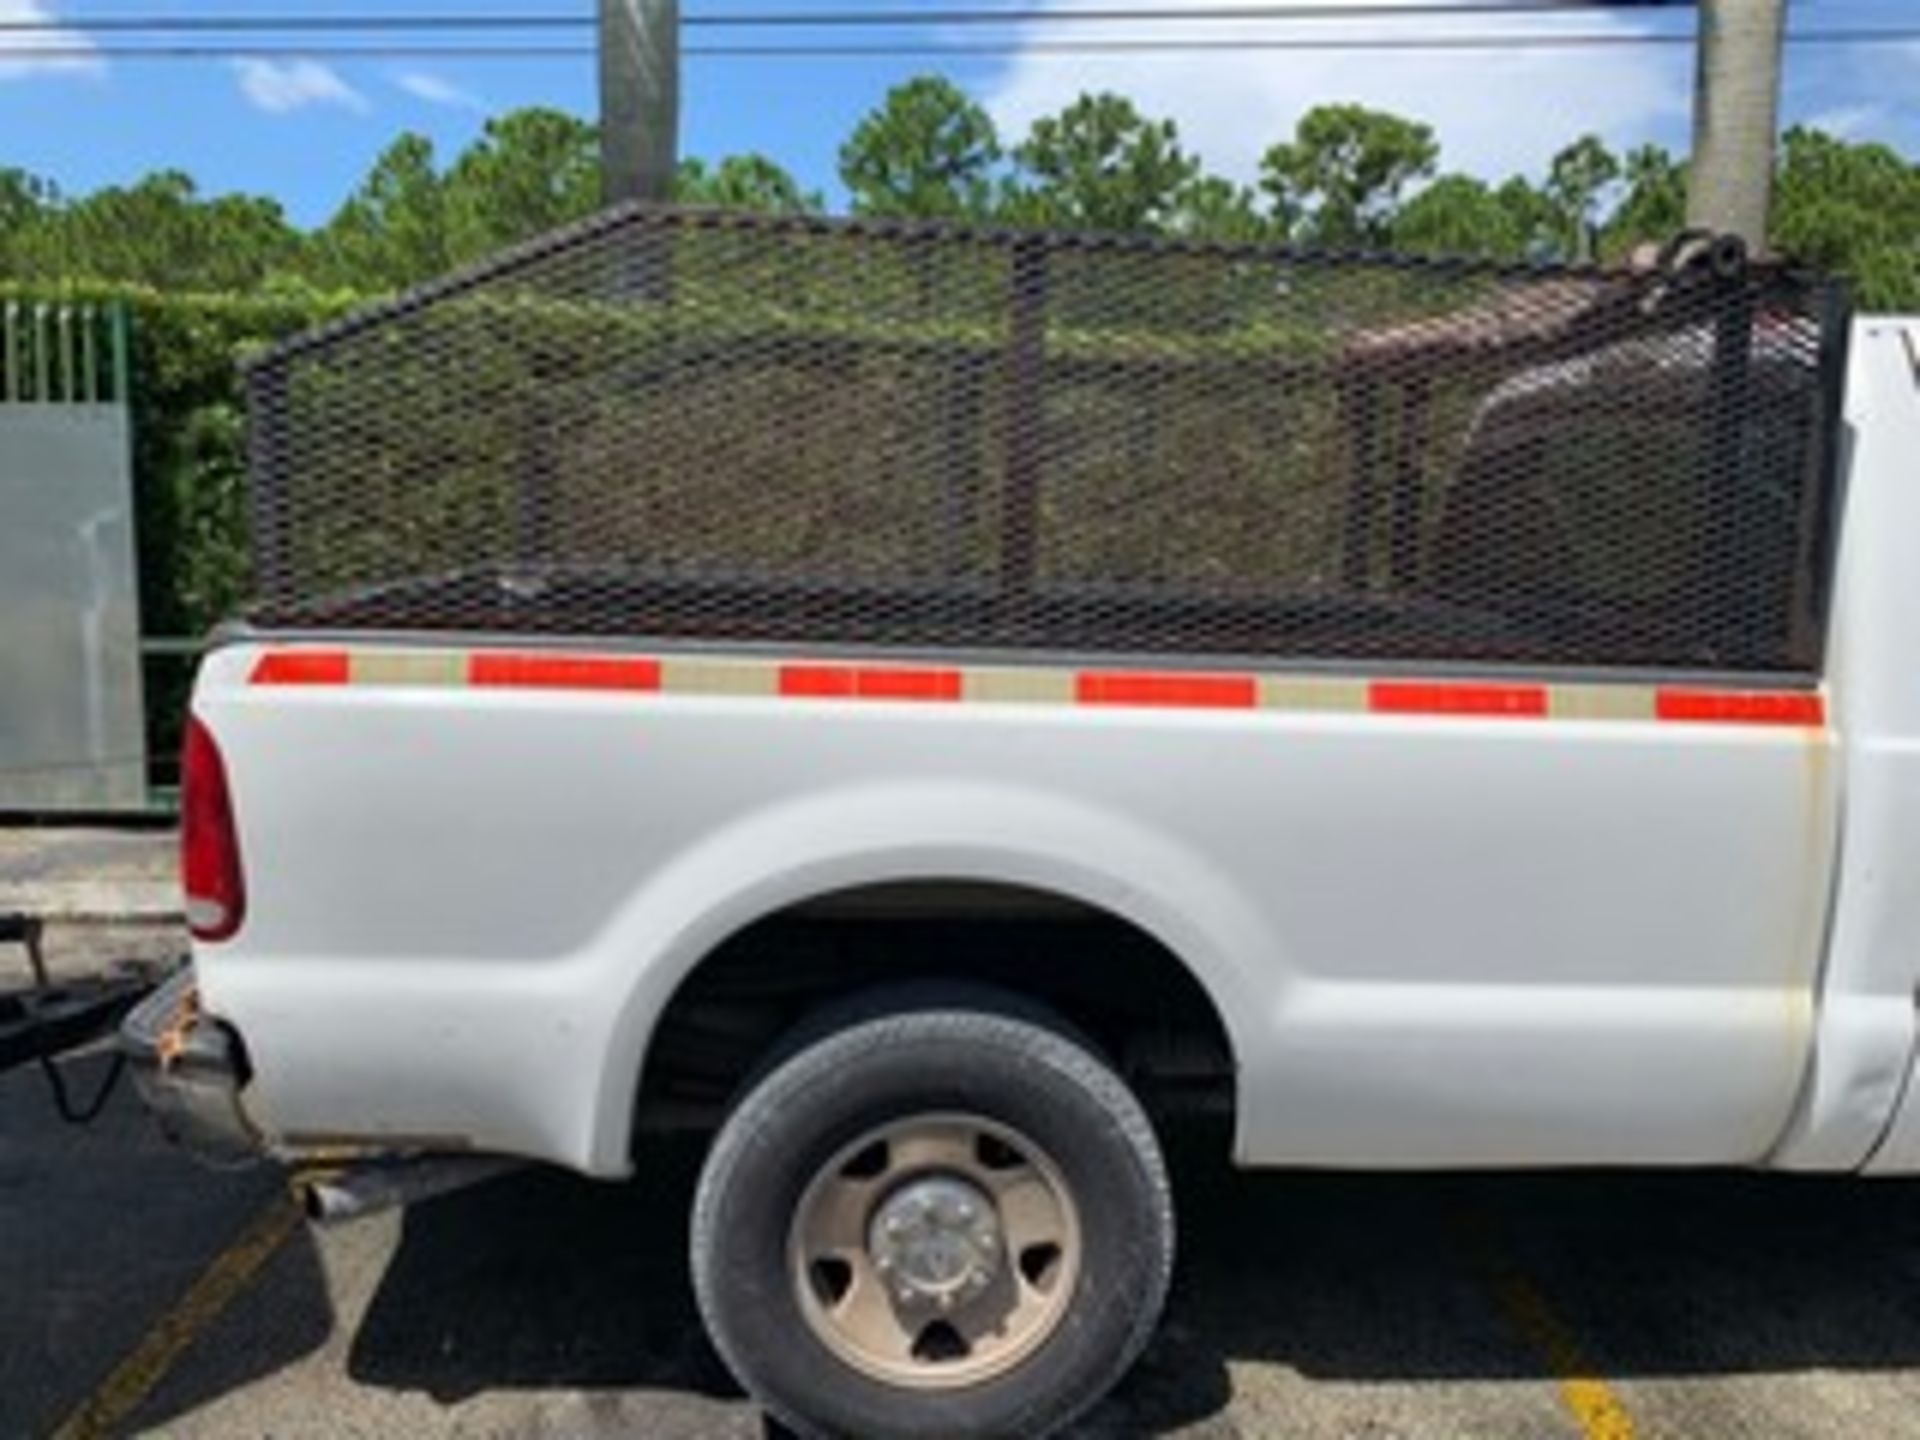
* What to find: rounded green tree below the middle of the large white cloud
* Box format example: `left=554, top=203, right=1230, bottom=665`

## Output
left=1260, top=106, right=1440, bottom=250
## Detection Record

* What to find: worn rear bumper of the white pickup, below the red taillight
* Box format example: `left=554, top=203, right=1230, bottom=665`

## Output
left=119, top=966, right=263, bottom=1164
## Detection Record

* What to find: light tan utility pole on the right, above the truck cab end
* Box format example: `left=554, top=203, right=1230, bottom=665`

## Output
left=1686, top=0, right=1788, bottom=253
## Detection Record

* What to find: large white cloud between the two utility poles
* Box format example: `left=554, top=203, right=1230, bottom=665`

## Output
left=985, top=0, right=1692, bottom=180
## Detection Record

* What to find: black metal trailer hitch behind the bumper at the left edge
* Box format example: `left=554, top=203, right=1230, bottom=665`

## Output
left=0, top=912, right=156, bottom=1125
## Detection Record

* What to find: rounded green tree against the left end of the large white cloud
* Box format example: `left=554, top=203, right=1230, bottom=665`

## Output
left=1000, top=94, right=1200, bottom=230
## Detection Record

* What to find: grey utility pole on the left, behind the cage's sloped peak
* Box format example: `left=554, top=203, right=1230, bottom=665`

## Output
left=599, top=0, right=680, bottom=205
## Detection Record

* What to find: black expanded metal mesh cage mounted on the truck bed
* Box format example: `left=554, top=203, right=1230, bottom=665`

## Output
left=248, top=207, right=1847, bottom=674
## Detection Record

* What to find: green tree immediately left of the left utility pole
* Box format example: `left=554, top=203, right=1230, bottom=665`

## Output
left=444, top=108, right=601, bottom=263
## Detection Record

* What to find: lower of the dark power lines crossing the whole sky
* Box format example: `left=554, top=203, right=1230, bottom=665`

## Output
left=0, top=27, right=1920, bottom=61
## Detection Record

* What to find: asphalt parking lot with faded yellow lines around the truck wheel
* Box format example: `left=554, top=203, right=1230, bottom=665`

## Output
left=11, top=843, right=1920, bottom=1440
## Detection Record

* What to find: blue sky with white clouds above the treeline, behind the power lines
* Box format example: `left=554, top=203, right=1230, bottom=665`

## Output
left=0, top=0, right=1920, bottom=225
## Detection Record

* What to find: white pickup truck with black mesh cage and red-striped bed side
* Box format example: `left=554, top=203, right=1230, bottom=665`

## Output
left=127, top=211, right=1896, bottom=1436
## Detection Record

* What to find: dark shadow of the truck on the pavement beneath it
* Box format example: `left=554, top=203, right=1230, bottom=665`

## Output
left=349, top=1146, right=1920, bottom=1434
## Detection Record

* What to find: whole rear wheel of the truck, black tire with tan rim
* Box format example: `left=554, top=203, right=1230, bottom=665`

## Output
left=693, top=989, right=1173, bottom=1440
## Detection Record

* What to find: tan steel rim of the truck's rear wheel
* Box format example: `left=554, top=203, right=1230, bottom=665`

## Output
left=787, top=1114, right=1081, bottom=1390
